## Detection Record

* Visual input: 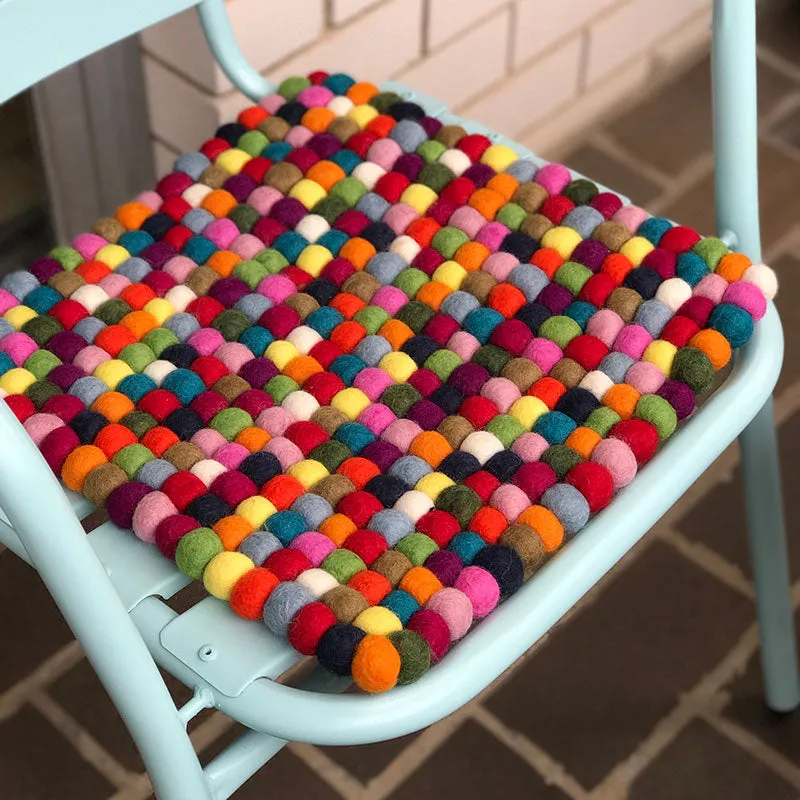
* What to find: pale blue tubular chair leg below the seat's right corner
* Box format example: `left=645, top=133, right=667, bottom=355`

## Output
left=739, top=399, right=800, bottom=712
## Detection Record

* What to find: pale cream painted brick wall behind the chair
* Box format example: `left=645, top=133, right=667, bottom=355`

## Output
left=142, top=0, right=711, bottom=172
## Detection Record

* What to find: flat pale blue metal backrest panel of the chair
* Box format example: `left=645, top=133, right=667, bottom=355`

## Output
left=0, top=0, right=200, bottom=103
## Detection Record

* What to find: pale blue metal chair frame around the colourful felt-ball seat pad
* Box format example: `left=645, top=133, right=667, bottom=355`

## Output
left=0, top=0, right=800, bottom=800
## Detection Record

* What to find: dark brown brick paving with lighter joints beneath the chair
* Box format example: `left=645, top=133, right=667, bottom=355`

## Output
left=0, top=0, right=800, bottom=800
